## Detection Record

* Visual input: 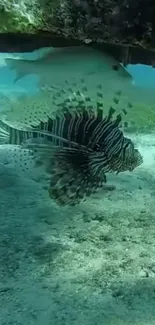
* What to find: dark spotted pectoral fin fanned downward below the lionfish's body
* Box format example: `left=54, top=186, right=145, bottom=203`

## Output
left=49, top=148, right=105, bottom=205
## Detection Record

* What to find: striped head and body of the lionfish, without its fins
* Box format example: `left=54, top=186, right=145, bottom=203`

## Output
left=31, top=108, right=142, bottom=174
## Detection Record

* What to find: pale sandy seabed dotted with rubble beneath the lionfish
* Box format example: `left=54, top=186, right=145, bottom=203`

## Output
left=0, top=135, right=155, bottom=325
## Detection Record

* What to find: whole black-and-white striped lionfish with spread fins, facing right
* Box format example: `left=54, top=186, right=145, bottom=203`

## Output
left=1, top=81, right=143, bottom=205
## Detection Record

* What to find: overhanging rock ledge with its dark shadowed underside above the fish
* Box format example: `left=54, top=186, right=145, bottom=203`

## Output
left=0, top=0, right=155, bottom=65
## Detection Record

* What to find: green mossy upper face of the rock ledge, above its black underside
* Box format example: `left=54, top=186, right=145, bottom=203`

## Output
left=0, top=0, right=154, bottom=48
